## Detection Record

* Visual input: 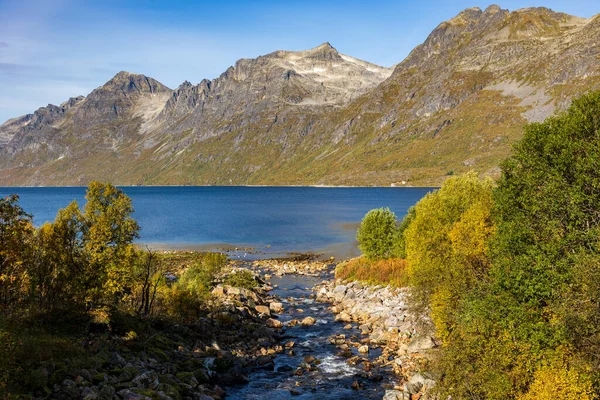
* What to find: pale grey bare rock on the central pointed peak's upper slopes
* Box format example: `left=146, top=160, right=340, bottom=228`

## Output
left=152, top=43, right=392, bottom=140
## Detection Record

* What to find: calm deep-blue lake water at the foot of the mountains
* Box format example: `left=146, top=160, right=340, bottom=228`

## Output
left=0, top=186, right=432, bottom=257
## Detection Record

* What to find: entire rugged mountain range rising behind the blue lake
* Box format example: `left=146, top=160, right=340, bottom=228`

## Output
left=0, top=5, right=600, bottom=186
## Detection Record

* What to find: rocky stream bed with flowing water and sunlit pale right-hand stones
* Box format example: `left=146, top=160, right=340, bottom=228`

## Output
left=227, top=261, right=436, bottom=400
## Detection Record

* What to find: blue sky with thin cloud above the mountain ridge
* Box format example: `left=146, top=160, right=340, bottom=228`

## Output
left=0, top=0, right=600, bottom=123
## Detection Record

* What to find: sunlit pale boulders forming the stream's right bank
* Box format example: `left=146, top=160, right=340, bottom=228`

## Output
left=315, top=281, right=437, bottom=400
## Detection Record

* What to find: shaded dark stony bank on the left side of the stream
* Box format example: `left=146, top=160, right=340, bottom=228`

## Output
left=42, top=270, right=284, bottom=400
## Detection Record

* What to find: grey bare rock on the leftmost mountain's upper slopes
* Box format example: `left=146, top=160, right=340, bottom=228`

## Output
left=0, top=72, right=171, bottom=173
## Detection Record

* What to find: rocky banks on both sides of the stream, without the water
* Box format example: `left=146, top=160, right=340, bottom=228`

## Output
left=39, top=260, right=436, bottom=400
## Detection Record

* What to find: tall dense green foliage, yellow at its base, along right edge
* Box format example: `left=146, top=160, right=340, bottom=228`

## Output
left=440, top=93, right=600, bottom=400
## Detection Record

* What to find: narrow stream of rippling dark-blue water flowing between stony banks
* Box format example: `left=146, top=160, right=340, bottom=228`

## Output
left=227, top=275, right=394, bottom=399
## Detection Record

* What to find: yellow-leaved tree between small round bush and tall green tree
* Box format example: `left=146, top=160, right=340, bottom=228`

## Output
left=403, top=173, right=494, bottom=340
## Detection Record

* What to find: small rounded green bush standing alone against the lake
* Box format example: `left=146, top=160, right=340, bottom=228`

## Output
left=356, top=208, right=397, bottom=260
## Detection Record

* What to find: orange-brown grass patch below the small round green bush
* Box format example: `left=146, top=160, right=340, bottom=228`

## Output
left=335, top=257, right=407, bottom=287
